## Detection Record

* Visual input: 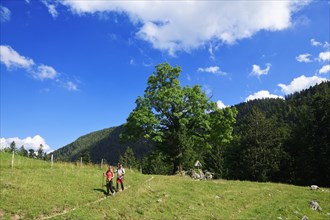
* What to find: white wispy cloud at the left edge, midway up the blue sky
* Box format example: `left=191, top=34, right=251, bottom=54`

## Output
left=0, top=45, right=34, bottom=69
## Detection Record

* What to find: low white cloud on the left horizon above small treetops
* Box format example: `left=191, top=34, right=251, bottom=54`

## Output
left=0, top=135, right=52, bottom=152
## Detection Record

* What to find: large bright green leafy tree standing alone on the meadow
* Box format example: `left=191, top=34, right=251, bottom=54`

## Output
left=122, top=63, right=236, bottom=172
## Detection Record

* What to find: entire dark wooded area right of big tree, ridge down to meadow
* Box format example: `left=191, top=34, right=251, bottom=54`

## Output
left=229, top=82, right=330, bottom=186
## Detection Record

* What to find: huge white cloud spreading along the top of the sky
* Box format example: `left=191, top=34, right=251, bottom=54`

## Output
left=60, top=0, right=310, bottom=55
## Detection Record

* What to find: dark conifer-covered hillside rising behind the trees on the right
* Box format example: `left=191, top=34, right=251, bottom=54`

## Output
left=234, top=81, right=330, bottom=131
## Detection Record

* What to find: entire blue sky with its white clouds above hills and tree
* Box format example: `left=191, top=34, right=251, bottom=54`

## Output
left=0, top=0, right=330, bottom=151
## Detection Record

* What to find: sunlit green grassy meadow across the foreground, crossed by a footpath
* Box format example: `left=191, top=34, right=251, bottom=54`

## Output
left=0, top=153, right=330, bottom=220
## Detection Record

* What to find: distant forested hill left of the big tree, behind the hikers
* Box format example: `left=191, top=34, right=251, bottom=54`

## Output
left=53, top=126, right=151, bottom=164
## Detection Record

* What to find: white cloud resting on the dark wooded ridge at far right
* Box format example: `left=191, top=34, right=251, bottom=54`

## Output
left=278, top=75, right=327, bottom=95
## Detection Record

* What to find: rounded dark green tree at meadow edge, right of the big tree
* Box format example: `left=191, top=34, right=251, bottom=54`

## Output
left=235, top=108, right=283, bottom=181
